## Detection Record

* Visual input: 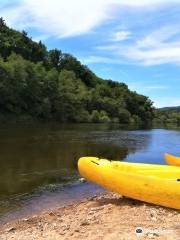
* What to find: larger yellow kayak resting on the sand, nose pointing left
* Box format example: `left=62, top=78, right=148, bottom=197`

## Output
left=78, top=157, right=180, bottom=209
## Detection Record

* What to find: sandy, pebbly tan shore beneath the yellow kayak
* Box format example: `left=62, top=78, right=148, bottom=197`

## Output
left=0, top=193, right=180, bottom=240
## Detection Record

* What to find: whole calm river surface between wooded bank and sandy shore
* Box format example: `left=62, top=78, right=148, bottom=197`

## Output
left=0, top=124, right=180, bottom=223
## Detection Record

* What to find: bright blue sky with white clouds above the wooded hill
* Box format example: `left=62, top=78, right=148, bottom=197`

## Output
left=0, top=0, right=180, bottom=107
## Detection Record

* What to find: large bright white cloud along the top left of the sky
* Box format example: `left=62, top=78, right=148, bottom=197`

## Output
left=0, top=0, right=179, bottom=38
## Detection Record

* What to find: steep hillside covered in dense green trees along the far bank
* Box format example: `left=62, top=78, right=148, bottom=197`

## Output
left=0, top=18, right=154, bottom=124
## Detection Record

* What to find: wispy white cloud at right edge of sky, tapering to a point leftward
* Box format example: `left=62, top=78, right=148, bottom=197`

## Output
left=96, top=24, right=180, bottom=66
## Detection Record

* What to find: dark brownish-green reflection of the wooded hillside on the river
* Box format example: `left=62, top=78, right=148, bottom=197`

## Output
left=0, top=125, right=148, bottom=201
